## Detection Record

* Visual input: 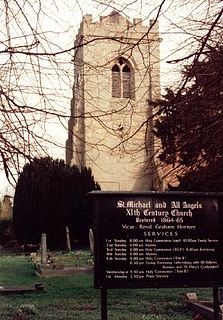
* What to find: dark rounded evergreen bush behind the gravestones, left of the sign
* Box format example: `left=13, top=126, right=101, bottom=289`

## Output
left=13, top=157, right=99, bottom=249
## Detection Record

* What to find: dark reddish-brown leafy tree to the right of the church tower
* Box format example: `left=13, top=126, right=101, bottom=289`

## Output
left=155, top=47, right=223, bottom=191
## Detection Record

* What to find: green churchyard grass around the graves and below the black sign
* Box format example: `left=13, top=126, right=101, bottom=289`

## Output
left=0, top=251, right=212, bottom=320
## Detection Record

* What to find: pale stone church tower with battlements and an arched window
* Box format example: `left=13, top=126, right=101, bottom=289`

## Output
left=66, top=11, right=160, bottom=191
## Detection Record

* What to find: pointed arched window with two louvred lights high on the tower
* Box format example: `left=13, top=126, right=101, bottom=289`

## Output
left=112, top=58, right=134, bottom=99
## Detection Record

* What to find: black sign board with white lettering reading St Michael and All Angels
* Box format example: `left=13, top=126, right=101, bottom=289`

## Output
left=90, top=191, right=223, bottom=288
